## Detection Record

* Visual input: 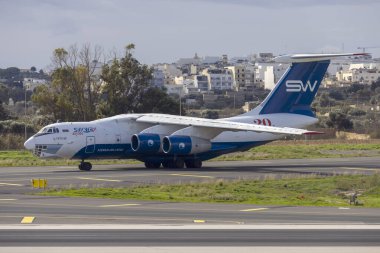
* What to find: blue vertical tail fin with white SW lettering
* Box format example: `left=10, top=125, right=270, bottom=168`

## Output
left=255, top=60, right=330, bottom=117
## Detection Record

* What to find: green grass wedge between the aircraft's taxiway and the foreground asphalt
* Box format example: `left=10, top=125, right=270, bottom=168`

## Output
left=41, top=174, right=380, bottom=207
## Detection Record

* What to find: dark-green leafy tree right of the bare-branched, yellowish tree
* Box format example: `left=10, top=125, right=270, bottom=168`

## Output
left=100, top=44, right=152, bottom=116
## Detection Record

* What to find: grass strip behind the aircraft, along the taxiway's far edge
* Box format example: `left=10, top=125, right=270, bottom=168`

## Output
left=0, top=140, right=380, bottom=167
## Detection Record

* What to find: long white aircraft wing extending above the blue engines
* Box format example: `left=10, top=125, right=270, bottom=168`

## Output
left=136, top=114, right=318, bottom=135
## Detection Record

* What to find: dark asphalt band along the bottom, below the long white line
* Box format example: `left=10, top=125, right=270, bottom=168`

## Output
left=0, top=226, right=380, bottom=247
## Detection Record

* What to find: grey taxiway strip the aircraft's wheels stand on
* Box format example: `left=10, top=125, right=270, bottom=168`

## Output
left=0, top=157, right=380, bottom=194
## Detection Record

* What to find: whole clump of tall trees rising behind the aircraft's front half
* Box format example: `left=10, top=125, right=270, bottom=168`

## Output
left=32, top=44, right=179, bottom=121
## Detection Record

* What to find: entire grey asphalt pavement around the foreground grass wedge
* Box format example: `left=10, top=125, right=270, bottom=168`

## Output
left=0, top=158, right=380, bottom=247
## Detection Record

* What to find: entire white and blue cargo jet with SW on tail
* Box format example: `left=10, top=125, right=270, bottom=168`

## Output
left=24, top=54, right=363, bottom=171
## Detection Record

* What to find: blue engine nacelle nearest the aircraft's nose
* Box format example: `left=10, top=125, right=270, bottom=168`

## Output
left=131, top=134, right=161, bottom=153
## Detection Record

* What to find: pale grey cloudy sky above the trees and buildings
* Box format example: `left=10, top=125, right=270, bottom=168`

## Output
left=0, top=0, right=380, bottom=69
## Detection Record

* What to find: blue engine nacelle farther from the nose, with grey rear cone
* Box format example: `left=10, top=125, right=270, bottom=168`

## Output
left=162, top=135, right=211, bottom=155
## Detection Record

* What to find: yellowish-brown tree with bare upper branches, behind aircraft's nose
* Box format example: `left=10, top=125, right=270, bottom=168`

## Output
left=32, top=44, right=101, bottom=121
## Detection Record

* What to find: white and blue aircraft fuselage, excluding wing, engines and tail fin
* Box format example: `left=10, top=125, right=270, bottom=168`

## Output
left=25, top=113, right=317, bottom=160
